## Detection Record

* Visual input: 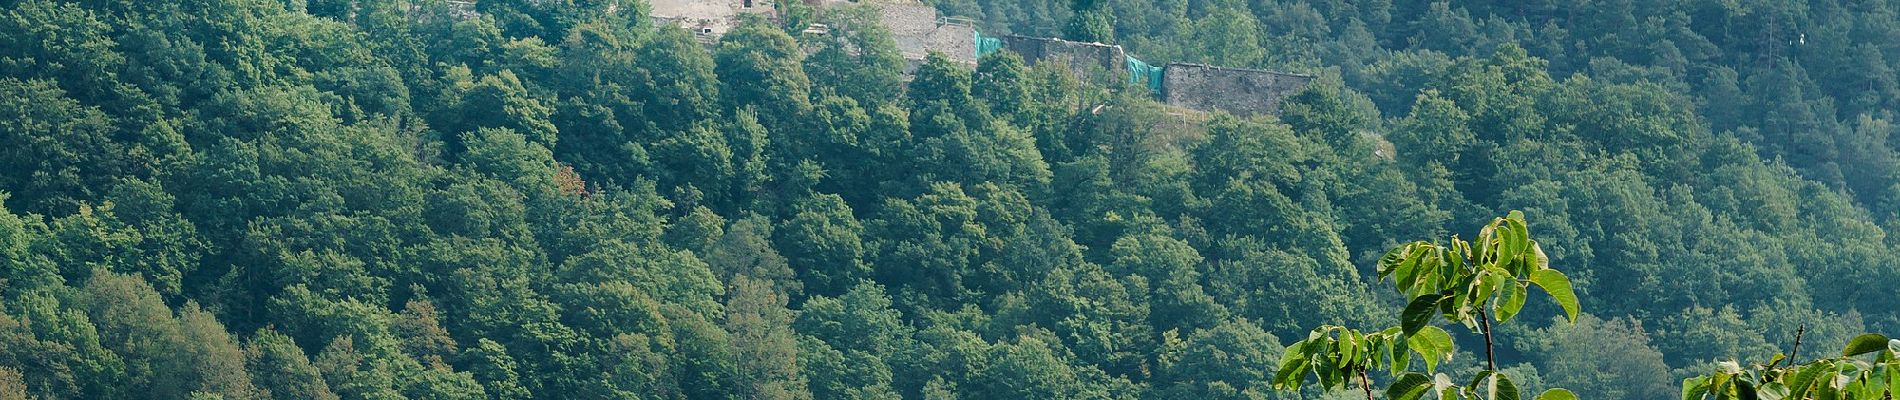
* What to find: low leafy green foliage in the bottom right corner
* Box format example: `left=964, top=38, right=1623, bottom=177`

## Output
left=1682, top=334, right=1900, bottom=400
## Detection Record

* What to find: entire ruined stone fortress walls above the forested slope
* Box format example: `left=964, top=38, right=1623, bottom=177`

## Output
left=652, top=0, right=1313, bottom=116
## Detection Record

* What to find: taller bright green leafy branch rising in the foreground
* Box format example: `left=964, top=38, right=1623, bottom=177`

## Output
left=1273, top=210, right=1581, bottom=400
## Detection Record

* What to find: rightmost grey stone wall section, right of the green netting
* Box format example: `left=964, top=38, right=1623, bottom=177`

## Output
left=1161, top=63, right=1313, bottom=116
